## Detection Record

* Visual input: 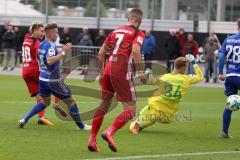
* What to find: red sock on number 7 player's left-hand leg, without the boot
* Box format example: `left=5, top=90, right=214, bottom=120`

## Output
left=91, top=107, right=106, bottom=138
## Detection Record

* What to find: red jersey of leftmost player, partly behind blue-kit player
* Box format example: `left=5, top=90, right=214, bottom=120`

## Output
left=22, top=37, right=41, bottom=76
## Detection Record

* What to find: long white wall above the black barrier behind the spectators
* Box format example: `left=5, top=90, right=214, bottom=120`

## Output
left=0, top=16, right=237, bottom=34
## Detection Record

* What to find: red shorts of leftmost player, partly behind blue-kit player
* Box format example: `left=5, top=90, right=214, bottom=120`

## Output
left=23, top=72, right=39, bottom=97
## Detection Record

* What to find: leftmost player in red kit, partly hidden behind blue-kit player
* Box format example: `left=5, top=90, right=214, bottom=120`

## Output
left=22, top=23, right=53, bottom=125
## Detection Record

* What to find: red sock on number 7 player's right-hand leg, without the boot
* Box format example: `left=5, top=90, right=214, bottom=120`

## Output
left=107, top=108, right=135, bottom=135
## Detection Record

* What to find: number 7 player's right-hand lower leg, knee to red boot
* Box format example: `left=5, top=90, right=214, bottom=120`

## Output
left=102, top=101, right=136, bottom=152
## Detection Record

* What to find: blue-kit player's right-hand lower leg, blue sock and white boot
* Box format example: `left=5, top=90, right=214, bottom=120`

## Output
left=62, top=98, right=91, bottom=130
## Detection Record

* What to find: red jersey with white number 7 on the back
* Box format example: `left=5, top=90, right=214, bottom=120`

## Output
left=104, top=26, right=144, bottom=79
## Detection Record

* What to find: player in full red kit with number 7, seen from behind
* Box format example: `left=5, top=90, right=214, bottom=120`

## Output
left=88, top=9, right=146, bottom=152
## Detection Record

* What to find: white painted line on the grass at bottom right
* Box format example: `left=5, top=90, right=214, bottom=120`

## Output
left=85, top=151, right=240, bottom=160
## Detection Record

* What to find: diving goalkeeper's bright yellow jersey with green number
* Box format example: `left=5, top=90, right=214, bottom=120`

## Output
left=148, top=64, right=203, bottom=113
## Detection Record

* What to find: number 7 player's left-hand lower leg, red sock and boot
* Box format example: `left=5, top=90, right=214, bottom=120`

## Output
left=88, top=98, right=112, bottom=152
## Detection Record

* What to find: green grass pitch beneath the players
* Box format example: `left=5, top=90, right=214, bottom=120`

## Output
left=0, top=76, right=240, bottom=160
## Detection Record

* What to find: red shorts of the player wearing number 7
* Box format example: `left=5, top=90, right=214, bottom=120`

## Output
left=100, top=74, right=136, bottom=102
